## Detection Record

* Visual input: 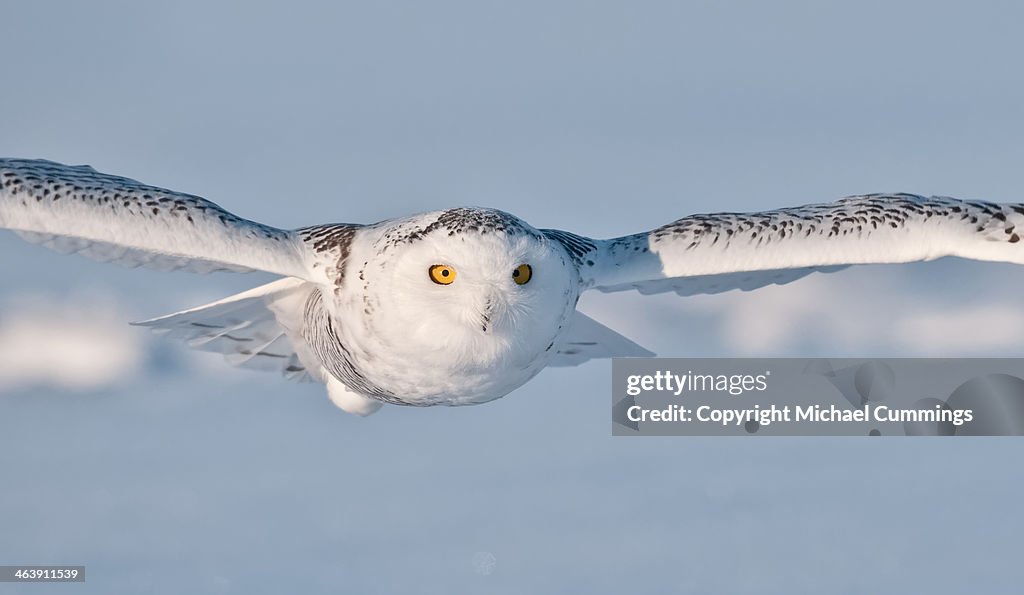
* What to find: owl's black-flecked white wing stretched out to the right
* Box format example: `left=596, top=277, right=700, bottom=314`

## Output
left=545, top=194, right=1024, bottom=295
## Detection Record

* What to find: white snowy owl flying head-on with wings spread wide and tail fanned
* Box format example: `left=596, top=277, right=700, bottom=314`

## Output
left=0, top=159, right=1024, bottom=415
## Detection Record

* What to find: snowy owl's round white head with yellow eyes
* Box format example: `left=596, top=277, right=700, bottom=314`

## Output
left=360, top=208, right=579, bottom=366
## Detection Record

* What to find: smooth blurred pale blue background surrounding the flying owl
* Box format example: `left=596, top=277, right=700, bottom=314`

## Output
left=0, top=0, right=1024, bottom=594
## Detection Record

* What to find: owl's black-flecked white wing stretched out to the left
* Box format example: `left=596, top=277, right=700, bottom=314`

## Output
left=0, top=159, right=313, bottom=279
